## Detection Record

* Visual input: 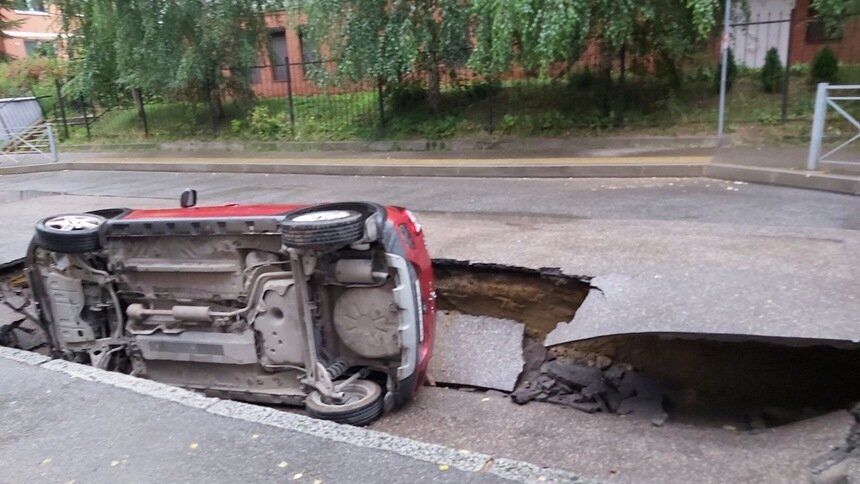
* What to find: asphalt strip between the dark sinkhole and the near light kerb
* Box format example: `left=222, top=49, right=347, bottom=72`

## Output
left=373, top=388, right=860, bottom=483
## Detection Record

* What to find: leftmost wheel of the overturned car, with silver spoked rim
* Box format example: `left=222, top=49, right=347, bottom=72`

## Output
left=36, top=213, right=105, bottom=254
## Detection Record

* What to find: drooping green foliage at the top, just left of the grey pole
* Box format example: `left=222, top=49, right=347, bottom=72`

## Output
left=469, top=0, right=719, bottom=74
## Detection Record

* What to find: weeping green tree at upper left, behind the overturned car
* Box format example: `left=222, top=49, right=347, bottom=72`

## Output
left=57, top=0, right=267, bottom=125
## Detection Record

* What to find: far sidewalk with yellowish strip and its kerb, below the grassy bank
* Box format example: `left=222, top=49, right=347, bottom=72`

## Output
left=0, top=144, right=860, bottom=195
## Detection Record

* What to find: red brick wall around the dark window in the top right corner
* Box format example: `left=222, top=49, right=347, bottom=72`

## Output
left=791, top=0, right=860, bottom=64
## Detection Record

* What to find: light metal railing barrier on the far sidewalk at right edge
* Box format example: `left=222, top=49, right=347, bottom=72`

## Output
left=806, top=82, right=860, bottom=170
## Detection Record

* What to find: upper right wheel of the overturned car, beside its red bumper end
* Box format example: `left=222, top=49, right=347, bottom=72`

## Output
left=281, top=207, right=364, bottom=249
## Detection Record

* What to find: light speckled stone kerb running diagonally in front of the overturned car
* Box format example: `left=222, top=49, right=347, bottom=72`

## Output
left=0, top=346, right=593, bottom=483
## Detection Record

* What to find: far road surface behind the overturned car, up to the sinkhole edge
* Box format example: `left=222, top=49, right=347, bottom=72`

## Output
left=0, top=171, right=860, bottom=341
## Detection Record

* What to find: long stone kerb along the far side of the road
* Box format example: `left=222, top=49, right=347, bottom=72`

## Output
left=0, top=160, right=860, bottom=195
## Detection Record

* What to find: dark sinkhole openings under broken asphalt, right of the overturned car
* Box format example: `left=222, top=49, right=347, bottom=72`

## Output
left=434, top=260, right=860, bottom=430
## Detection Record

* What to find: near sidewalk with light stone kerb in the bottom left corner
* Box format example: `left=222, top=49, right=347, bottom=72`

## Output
left=0, top=347, right=581, bottom=484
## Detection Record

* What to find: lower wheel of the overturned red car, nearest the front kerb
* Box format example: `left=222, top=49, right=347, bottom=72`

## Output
left=305, top=380, right=382, bottom=426
